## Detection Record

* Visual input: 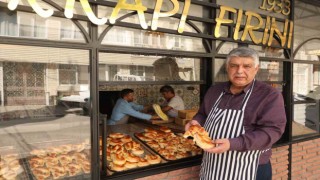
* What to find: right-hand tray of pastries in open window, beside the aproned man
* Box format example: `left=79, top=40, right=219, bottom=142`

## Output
left=134, top=126, right=202, bottom=161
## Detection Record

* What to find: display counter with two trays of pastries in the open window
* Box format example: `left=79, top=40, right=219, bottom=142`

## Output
left=100, top=122, right=202, bottom=179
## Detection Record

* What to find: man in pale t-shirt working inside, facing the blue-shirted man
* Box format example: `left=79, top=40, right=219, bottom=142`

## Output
left=160, top=85, right=184, bottom=117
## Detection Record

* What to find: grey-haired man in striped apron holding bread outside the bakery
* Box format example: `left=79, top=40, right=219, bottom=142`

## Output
left=185, top=47, right=286, bottom=180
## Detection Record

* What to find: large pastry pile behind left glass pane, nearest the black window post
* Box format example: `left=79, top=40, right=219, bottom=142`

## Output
left=28, top=143, right=91, bottom=179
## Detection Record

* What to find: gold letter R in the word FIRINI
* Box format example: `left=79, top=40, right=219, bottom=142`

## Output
left=241, top=11, right=263, bottom=44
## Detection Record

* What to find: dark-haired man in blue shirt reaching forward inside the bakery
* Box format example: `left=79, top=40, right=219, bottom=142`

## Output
left=107, top=89, right=160, bottom=125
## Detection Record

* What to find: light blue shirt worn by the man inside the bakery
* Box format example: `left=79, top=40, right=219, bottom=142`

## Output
left=108, top=98, right=151, bottom=125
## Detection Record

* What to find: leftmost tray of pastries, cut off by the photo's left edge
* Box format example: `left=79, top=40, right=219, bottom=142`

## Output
left=0, top=146, right=27, bottom=179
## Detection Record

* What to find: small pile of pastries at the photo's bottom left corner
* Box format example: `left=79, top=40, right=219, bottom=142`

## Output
left=0, top=153, right=23, bottom=179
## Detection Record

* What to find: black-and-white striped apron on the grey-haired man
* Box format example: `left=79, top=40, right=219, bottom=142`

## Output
left=200, top=82, right=262, bottom=180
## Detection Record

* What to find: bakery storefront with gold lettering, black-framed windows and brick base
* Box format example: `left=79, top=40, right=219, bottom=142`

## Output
left=0, top=0, right=320, bottom=179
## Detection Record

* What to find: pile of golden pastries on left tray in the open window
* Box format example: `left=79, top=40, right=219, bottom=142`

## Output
left=105, top=133, right=161, bottom=171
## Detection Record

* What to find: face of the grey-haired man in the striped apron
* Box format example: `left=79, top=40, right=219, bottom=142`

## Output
left=227, top=57, right=259, bottom=87
